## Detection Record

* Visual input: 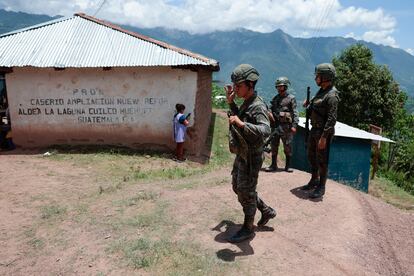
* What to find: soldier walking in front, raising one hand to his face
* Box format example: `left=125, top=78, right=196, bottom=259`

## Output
left=226, top=64, right=276, bottom=243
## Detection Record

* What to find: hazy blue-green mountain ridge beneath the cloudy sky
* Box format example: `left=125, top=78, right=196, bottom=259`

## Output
left=0, top=10, right=414, bottom=100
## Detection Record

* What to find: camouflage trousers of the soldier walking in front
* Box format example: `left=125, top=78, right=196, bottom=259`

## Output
left=231, top=152, right=269, bottom=217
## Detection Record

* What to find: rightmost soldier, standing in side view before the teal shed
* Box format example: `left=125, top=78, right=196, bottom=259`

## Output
left=301, top=63, right=339, bottom=198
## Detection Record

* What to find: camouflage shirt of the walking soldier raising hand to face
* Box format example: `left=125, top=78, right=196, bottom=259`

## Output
left=230, top=94, right=270, bottom=153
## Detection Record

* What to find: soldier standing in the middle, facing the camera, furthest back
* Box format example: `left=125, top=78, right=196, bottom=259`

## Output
left=265, top=77, right=299, bottom=172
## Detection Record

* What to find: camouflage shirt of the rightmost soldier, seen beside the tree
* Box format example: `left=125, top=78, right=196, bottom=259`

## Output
left=309, top=86, right=339, bottom=137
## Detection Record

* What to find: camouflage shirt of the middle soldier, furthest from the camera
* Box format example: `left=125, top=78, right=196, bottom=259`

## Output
left=270, top=93, right=299, bottom=128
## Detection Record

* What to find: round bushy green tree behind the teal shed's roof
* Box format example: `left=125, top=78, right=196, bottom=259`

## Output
left=333, top=44, right=406, bottom=131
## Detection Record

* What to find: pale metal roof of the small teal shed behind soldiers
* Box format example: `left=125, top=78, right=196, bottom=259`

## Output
left=299, top=117, right=394, bottom=143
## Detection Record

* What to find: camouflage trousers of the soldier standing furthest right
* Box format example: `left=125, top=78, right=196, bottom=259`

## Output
left=307, top=128, right=332, bottom=178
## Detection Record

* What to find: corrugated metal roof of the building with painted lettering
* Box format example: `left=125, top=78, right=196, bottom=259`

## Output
left=0, top=14, right=219, bottom=70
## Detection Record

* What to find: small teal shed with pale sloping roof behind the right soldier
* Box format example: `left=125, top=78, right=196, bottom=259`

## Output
left=292, top=118, right=394, bottom=192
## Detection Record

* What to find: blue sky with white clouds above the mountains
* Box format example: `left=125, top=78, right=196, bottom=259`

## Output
left=0, top=0, right=414, bottom=54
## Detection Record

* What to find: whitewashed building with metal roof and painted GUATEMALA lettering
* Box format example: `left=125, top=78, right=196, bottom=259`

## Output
left=0, top=14, right=219, bottom=155
